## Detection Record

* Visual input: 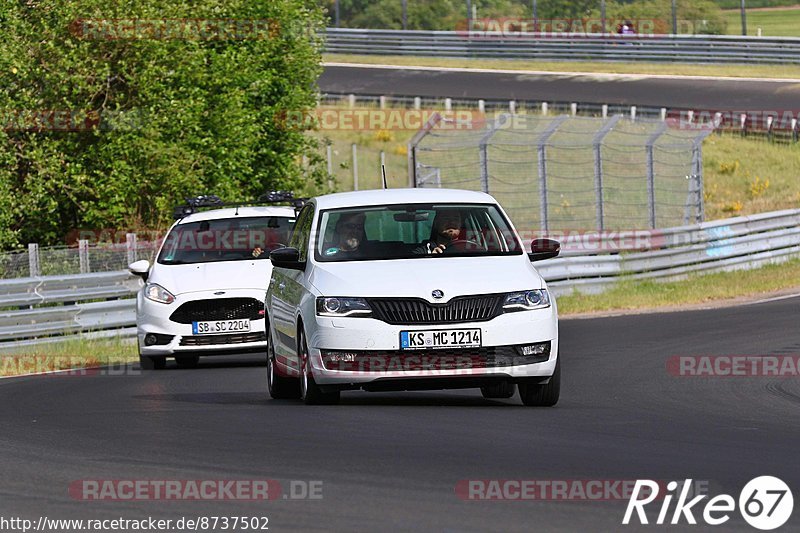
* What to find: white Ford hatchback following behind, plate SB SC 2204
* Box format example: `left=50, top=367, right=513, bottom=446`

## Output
left=129, top=196, right=295, bottom=369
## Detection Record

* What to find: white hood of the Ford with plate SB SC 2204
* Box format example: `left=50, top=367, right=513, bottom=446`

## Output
left=147, top=259, right=272, bottom=296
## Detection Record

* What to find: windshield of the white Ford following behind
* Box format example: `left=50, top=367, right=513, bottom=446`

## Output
left=158, top=216, right=295, bottom=265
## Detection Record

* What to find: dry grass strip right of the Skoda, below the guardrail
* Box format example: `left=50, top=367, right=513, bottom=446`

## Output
left=558, top=258, right=800, bottom=316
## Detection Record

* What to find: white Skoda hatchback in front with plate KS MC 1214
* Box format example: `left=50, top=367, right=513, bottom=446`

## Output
left=266, top=189, right=560, bottom=406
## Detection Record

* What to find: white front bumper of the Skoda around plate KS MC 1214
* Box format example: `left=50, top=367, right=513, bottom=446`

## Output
left=308, top=307, right=558, bottom=389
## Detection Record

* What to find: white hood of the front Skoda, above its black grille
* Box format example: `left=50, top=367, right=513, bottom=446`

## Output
left=309, top=256, right=544, bottom=303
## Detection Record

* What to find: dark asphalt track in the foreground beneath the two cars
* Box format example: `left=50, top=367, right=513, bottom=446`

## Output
left=0, top=298, right=800, bottom=532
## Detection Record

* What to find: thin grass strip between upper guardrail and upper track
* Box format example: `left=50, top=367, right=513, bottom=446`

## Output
left=323, top=53, right=800, bottom=79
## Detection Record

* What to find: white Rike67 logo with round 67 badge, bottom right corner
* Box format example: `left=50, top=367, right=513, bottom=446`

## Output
left=622, top=476, right=794, bottom=531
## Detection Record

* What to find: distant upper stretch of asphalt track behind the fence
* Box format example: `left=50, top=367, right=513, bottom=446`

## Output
left=319, top=65, right=800, bottom=112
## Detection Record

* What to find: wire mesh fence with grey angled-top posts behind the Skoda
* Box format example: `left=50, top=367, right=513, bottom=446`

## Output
left=409, top=114, right=713, bottom=231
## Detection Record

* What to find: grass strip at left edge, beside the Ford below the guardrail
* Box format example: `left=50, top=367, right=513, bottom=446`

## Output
left=0, top=337, right=139, bottom=376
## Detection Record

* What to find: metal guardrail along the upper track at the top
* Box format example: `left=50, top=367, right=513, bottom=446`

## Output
left=325, top=28, right=800, bottom=64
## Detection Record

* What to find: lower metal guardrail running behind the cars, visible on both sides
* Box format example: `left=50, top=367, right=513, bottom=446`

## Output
left=0, top=209, right=800, bottom=350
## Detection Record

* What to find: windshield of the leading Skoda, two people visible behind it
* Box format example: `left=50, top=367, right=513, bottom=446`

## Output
left=315, top=204, right=523, bottom=262
